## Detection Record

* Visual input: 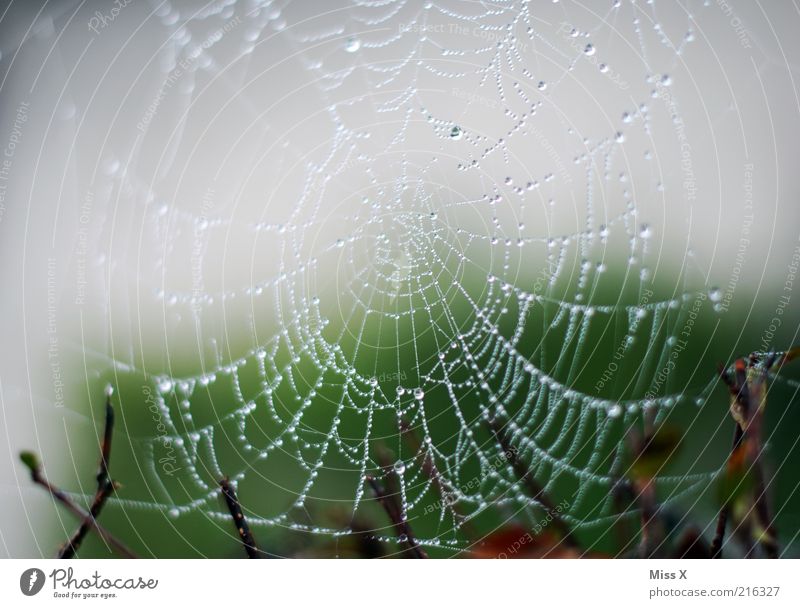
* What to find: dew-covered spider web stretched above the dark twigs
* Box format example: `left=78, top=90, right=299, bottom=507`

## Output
left=61, top=0, right=764, bottom=554
